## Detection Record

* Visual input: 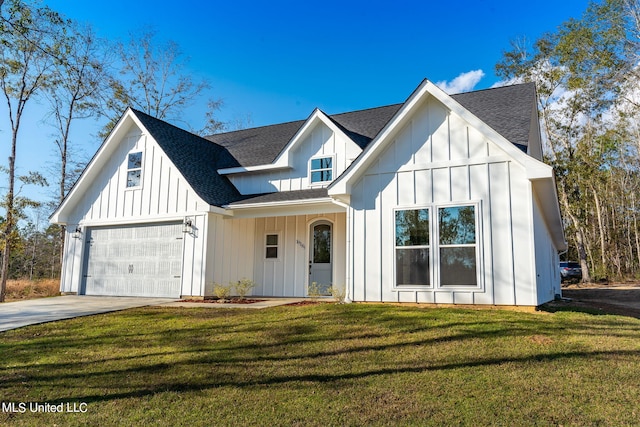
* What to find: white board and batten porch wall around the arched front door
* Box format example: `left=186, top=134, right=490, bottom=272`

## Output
left=253, top=213, right=346, bottom=297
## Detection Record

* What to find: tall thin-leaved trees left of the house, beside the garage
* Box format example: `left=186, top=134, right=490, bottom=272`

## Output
left=0, top=0, right=238, bottom=302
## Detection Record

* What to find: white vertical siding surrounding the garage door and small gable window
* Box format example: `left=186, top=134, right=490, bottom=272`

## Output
left=60, top=125, right=208, bottom=295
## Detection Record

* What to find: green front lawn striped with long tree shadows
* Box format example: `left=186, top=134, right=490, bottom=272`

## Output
left=0, top=304, right=640, bottom=426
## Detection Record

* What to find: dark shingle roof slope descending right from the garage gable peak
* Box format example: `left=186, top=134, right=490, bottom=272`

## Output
left=131, top=109, right=243, bottom=206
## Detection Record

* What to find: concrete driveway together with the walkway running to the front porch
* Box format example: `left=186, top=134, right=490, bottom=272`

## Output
left=0, top=295, right=305, bottom=332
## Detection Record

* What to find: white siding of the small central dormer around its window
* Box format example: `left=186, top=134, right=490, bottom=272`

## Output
left=229, top=122, right=362, bottom=194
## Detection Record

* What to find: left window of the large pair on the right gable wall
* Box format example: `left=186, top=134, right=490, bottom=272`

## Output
left=395, top=209, right=431, bottom=286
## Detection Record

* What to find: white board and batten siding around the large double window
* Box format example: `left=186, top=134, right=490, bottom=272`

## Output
left=349, top=98, right=537, bottom=305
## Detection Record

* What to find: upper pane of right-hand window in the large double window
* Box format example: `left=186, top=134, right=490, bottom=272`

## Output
left=438, top=206, right=476, bottom=245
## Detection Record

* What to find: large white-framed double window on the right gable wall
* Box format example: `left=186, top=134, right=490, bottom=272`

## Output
left=395, top=205, right=478, bottom=287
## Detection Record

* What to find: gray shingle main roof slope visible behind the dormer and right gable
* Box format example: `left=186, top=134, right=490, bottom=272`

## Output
left=205, top=83, right=535, bottom=167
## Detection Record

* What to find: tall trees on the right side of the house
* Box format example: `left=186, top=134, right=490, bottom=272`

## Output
left=496, top=0, right=640, bottom=281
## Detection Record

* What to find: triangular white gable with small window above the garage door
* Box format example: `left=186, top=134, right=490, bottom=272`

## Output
left=51, top=112, right=220, bottom=224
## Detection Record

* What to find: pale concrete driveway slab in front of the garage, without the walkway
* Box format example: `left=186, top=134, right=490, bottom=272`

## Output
left=0, top=295, right=176, bottom=332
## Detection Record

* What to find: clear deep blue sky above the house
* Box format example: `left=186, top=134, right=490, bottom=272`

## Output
left=0, top=0, right=587, bottom=207
